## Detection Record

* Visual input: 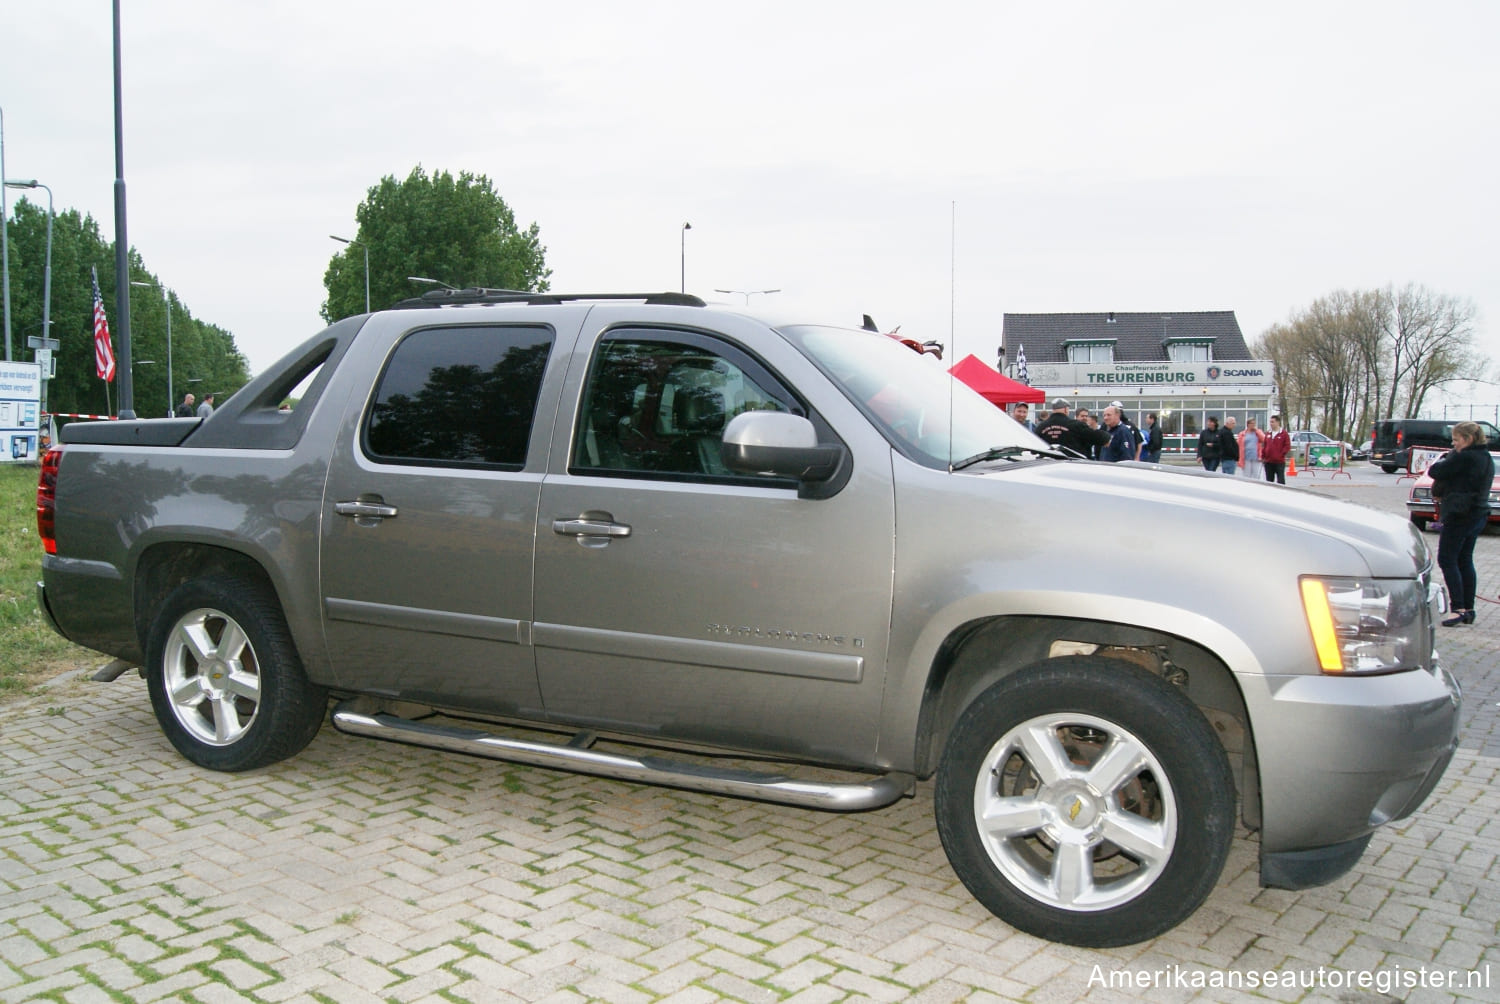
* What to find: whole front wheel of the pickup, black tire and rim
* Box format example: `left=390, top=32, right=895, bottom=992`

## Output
left=936, top=657, right=1235, bottom=948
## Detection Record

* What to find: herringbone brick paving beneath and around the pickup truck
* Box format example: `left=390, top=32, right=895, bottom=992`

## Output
left=0, top=479, right=1500, bottom=1004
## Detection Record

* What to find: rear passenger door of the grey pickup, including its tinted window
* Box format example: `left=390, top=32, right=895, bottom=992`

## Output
left=321, top=311, right=557, bottom=717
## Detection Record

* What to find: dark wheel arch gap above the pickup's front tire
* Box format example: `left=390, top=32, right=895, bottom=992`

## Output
left=915, top=615, right=1260, bottom=828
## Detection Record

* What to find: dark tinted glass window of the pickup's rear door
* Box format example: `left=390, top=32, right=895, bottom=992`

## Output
left=365, top=326, right=552, bottom=470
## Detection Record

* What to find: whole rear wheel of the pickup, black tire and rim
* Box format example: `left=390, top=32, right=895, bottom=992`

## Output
left=146, top=578, right=329, bottom=771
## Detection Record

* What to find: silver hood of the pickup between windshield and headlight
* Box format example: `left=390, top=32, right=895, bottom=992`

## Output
left=983, top=461, right=1431, bottom=578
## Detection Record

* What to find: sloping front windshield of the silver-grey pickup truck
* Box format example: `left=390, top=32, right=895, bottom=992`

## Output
left=782, top=326, right=1050, bottom=470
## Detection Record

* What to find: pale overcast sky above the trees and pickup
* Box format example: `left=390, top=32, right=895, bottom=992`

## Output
left=0, top=0, right=1500, bottom=404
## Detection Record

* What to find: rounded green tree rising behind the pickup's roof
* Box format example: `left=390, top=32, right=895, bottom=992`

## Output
left=323, top=165, right=552, bottom=324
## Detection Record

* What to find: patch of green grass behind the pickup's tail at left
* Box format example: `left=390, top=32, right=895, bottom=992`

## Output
left=0, top=464, right=99, bottom=701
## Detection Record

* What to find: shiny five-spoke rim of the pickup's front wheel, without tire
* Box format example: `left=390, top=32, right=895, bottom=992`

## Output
left=974, top=713, right=1178, bottom=911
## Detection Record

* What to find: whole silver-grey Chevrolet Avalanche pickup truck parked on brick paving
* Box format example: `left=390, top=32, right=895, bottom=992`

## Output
left=38, top=290, right=1460, bottom=945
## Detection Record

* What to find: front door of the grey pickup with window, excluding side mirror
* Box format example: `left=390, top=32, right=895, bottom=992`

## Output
left=534, top=311, right=894, bottom=762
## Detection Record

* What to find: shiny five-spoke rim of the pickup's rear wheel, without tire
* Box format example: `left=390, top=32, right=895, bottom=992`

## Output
left=162, top=608, right=261, bottom=746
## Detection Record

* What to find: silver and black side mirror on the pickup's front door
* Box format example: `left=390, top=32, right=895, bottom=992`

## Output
left=720, top=411, right=849, bottom=498
